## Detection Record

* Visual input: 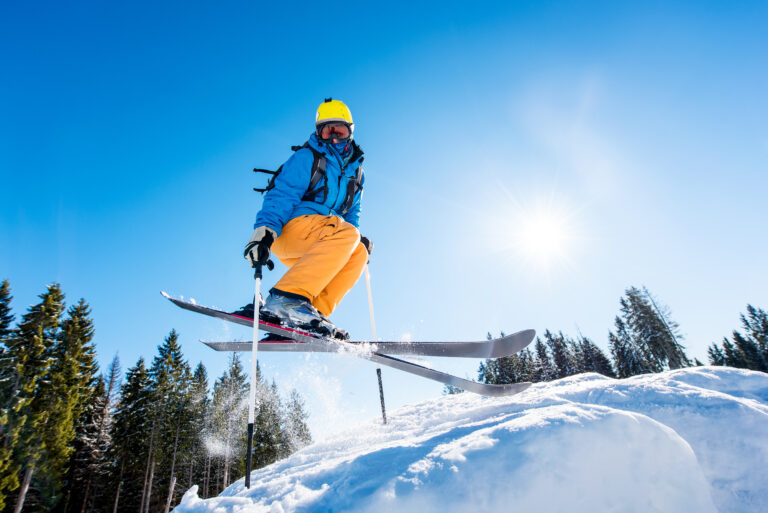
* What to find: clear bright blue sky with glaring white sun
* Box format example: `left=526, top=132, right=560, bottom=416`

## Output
left=0, top=2, right=768, bottom=435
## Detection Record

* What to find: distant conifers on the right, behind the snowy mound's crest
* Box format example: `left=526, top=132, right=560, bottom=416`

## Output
left=472, top=287, right=768, bottom=386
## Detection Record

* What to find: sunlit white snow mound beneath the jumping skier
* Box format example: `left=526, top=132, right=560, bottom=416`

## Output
left=174, top=367, right=768, bottom=513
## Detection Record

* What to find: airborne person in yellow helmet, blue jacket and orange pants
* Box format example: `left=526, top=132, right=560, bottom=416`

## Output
left=236, top=98, right=373, bottom=338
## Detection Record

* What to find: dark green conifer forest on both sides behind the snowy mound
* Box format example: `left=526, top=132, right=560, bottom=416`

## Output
left=0, top=280, right=768, bottom=513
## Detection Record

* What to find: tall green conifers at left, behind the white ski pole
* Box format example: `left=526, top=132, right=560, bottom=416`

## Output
left=0, top=280, right=311, bottom=513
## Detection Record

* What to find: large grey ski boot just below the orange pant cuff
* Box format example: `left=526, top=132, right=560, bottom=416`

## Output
left=259, top=289, right=336, bottom=337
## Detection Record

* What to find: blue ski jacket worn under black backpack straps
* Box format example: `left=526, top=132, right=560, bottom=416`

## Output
left=254, top=133, right=365, bottom=236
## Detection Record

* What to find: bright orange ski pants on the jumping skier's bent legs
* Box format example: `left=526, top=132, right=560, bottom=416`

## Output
left=272, top=215, right=368, bottom=316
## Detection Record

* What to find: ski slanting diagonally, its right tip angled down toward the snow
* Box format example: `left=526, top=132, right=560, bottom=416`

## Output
left=162, top=292, right=533, bottom=396
